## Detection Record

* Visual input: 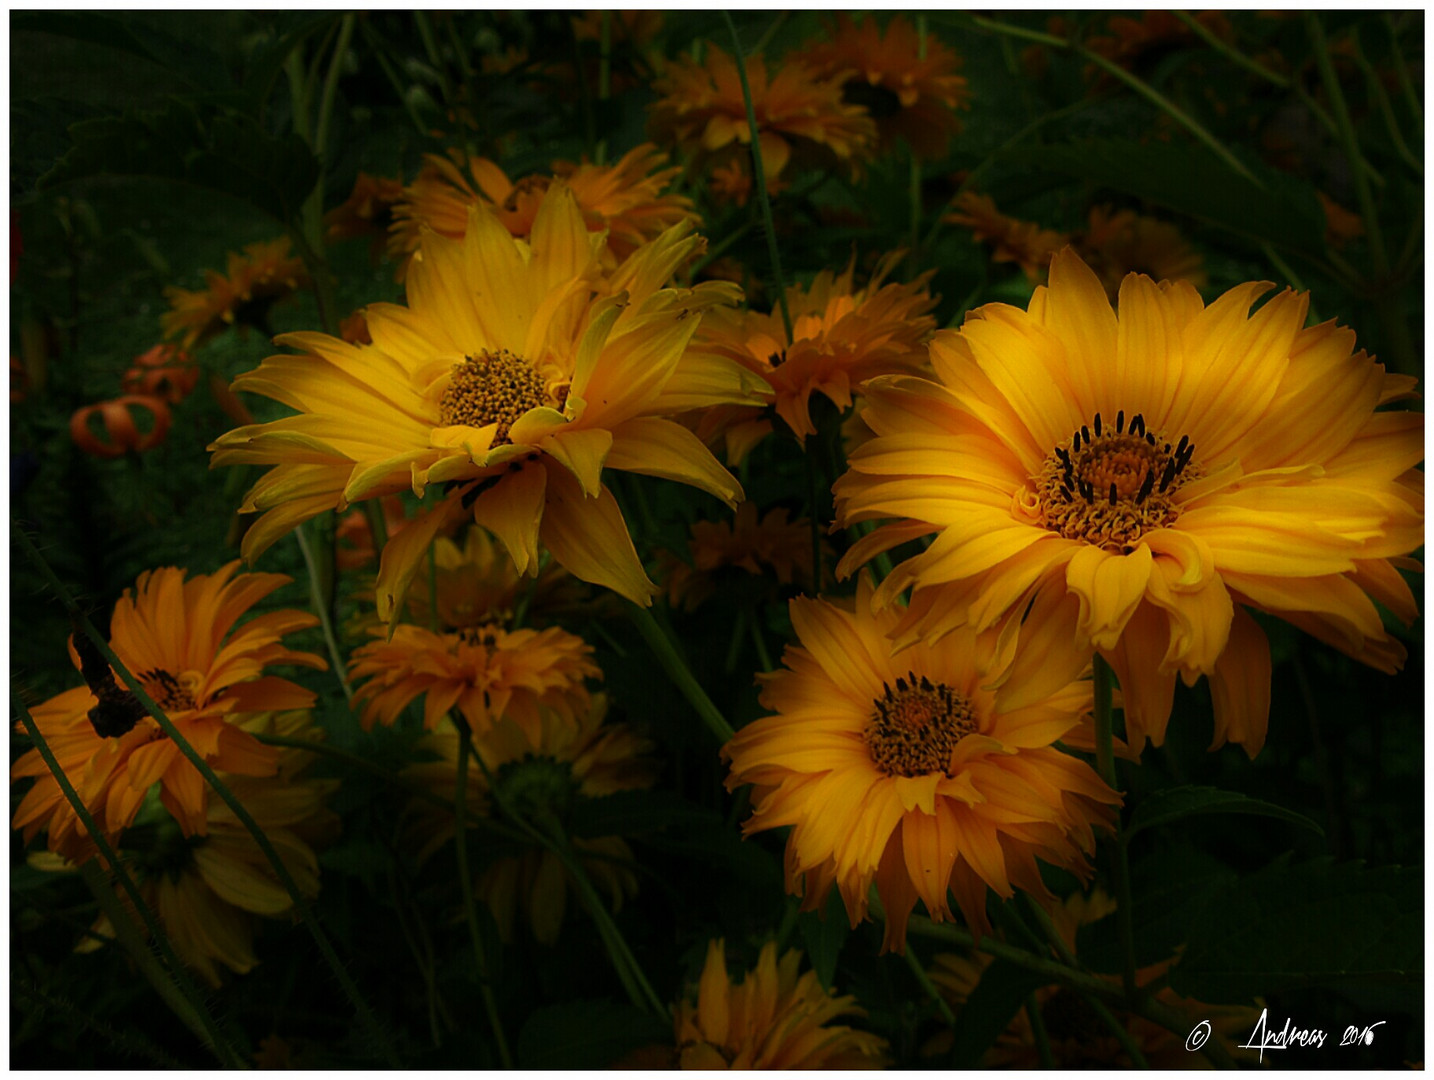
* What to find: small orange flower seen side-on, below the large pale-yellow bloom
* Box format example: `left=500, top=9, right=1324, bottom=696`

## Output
left=348, top=613, right=602, bottom=731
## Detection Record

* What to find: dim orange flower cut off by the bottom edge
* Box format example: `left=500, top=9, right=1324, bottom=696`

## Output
left=674, top=939, right=886, bottom=1070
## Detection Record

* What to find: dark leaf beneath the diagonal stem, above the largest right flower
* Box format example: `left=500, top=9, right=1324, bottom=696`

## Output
left=1004, top=139, right=1325, bottom=257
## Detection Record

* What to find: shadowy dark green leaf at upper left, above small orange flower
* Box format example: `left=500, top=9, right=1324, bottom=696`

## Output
left=40, top=100, right=318, bottom=222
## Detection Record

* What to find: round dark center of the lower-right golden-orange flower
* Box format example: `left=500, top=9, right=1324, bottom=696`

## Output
left=862, top=671, right=977, bottom=776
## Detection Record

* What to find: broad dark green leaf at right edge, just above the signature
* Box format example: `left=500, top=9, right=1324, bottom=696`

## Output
left=1170, top=856, right=1424, bottom=1004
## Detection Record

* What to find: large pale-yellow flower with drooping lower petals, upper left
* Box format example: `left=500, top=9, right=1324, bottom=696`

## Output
left=211, top=184, right=753, bottom=610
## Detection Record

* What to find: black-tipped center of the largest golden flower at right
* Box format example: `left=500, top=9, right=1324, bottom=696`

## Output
left=1035, top=409, right=1200, bottom=555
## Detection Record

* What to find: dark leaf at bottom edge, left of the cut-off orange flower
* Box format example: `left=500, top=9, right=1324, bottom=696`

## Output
left=518, top=1000, right=673, bottom=1069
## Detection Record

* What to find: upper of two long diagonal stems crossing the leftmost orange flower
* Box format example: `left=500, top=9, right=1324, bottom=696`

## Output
left=10, top=518, right=403, bottom=1069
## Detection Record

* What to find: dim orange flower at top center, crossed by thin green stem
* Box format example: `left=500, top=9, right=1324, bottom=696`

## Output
left=648, top=42, right=876, bottom=181
